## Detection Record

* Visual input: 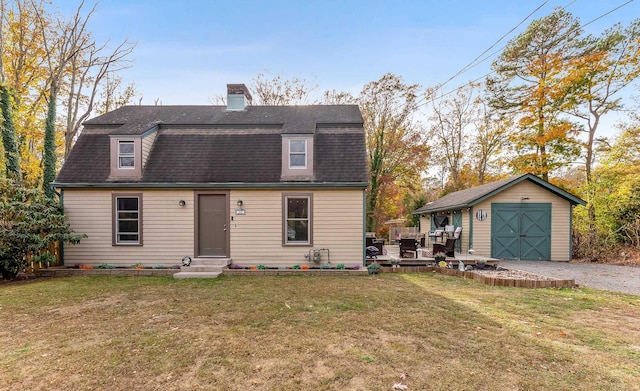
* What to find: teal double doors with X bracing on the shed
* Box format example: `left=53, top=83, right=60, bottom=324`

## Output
left=491, top=203, right=551, bottom=261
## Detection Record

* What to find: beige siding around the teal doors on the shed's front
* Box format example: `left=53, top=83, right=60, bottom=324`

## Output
left=466, top=181, right=571, bottom=261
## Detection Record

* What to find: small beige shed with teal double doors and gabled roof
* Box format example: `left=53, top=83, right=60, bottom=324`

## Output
left=413, top=174, right=586, bottom=261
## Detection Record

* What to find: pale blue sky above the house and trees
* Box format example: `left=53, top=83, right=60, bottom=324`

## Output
left=54, top=0, right=640, bottom=105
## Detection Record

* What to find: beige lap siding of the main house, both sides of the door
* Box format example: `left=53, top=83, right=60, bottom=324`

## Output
left=64, top=189, right=364, bottom=267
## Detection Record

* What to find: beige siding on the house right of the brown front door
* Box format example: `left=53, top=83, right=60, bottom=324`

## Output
left=230, top=189, right=364, bottom=266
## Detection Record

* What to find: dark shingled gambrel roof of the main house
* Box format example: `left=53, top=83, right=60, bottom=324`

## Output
left=55, top=105, right=368, bottom=187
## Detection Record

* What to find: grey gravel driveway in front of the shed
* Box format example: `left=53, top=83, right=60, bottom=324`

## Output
left=500, top=261, right=640, bottom=295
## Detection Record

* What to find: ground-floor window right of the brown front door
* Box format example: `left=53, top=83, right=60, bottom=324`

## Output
left=283, top=194, right=312, bottom=245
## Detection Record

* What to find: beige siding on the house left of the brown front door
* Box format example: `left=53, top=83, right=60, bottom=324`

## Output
left=64, top=189, right=193, bottom=267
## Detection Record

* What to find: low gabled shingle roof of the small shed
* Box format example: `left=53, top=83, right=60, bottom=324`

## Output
left=413, top=174, right=585, bottom=214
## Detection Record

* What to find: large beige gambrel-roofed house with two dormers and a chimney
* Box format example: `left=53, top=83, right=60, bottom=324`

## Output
left=53, top=84, right=368, bottom=272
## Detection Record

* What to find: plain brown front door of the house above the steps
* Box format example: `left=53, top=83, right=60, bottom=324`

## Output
left=196, top=194, right=229, bottom=257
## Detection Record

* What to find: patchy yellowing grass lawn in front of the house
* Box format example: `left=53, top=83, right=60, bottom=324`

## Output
left=0, top=274, right=640, bottom=390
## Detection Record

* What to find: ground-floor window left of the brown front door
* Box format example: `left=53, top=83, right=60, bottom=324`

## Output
left=113, top=194, right=142, bottom=245
